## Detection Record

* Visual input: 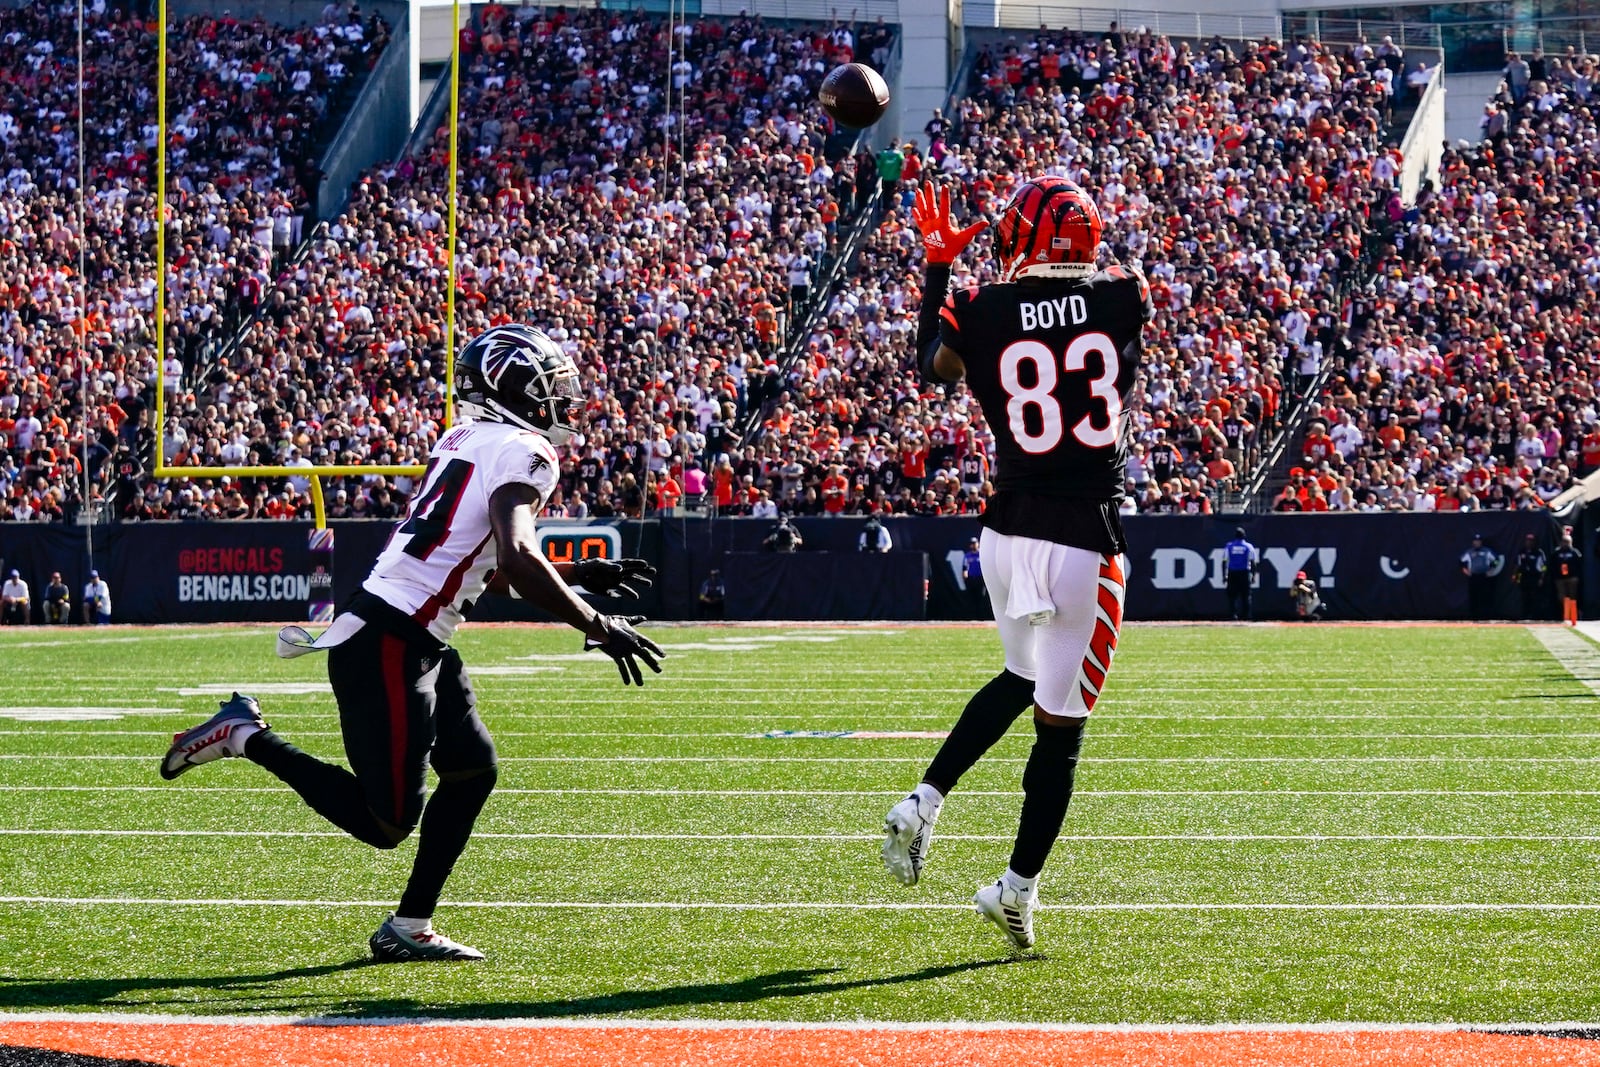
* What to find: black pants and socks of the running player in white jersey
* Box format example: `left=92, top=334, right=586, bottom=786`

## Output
left=245, top=593, right=498, bottom=918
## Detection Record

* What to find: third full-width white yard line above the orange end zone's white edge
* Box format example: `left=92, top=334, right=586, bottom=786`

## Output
left=18, top=785, right=1600, bottom=798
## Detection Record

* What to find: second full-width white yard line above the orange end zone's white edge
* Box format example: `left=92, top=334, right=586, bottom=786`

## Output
left=0, top=829, right=1600, bottom=845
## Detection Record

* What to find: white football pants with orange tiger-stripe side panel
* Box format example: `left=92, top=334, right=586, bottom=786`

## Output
left=978, top=528, right=1125, bottom=717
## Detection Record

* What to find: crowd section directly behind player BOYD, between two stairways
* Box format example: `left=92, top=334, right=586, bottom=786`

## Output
left=713, top=27, right=1397, bottom=514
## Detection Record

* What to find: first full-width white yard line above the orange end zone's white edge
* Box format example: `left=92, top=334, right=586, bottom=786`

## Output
left=0, top=896, right=1600, bottom=913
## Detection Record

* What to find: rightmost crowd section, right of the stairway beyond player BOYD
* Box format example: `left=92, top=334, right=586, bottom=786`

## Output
left=1275, top=53, right=1600, bottom=512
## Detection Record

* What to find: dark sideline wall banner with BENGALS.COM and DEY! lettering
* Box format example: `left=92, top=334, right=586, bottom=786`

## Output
left=0, top=512, right=1574, bottom=622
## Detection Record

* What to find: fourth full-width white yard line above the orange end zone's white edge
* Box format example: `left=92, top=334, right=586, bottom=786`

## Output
left=15, top=752, right=1600, bottom=765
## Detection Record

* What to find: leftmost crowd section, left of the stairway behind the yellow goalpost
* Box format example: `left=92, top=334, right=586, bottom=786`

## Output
left=0, top=3, right=389, bottom=520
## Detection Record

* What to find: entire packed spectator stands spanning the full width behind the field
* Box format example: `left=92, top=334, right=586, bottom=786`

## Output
left=0, top=5, right=1574, bottom=522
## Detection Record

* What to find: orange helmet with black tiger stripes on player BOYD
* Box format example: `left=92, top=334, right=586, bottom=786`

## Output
left=995, top=178, right=1102, bottom=282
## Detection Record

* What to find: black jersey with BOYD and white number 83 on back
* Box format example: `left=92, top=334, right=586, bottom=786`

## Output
left=939, top=267, right=1155, bottom=552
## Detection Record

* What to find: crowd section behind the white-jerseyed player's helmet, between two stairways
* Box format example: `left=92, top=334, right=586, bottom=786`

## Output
left=151, top=8, right=886, bottom=515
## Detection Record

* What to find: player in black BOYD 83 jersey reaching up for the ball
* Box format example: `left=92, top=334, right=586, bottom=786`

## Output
left=883, top=178, right=1154, bottom=949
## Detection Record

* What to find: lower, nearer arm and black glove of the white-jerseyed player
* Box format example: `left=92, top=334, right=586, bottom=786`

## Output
left=490, top=482, right=666, bottom=685
